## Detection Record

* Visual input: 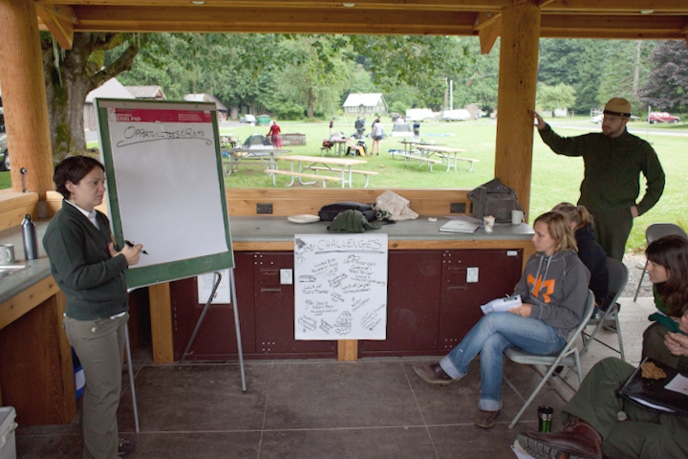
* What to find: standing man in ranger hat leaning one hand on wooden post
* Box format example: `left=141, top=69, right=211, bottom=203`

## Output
left=533, top=98, right=665, bottom=261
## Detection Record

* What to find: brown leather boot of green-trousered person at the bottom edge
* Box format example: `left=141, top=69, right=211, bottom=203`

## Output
left=518, top=417, right=602, bottom=459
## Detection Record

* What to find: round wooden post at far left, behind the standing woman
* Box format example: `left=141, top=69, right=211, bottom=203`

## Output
left=0, top=0, right=54, bottom=201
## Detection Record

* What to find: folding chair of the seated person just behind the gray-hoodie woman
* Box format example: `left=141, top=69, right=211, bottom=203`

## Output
left=580, top=258, right=628, bottom=361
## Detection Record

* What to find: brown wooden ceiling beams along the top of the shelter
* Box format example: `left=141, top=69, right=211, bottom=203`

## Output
left=35, top=0, right=688, bottom=47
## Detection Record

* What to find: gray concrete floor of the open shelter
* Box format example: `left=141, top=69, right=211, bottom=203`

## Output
left=16, top=298, right=654, bottom=459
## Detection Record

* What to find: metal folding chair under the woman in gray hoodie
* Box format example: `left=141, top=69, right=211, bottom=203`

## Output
left=504, top=290, right=595, bottom=429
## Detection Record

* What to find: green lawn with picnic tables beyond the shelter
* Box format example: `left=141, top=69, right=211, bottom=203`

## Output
left=0, top=117, right=688, bottom=250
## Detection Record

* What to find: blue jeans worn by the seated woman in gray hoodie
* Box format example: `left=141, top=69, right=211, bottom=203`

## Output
left=440, top=312, right=567, bottom=411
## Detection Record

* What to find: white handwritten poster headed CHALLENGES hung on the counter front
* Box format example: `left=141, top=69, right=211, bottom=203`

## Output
left=294, top=234, right=387, bottom=340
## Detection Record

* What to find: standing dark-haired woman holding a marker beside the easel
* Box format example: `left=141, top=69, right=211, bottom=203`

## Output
left=43, top=156, right=142, bottom=459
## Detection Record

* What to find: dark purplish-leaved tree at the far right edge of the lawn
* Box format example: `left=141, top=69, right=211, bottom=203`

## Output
left=640, top=40, right=688, bottom=111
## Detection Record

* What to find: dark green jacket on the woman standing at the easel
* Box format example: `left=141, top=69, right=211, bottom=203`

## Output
left=43, top=202, right=129, bottom=320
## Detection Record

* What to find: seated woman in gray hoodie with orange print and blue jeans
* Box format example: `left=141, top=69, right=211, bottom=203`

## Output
left=414, top=212, right=590, bottom=429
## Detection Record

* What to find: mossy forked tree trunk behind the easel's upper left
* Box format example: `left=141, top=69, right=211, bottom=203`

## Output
left=41, top=32, right=139, bottom=162
